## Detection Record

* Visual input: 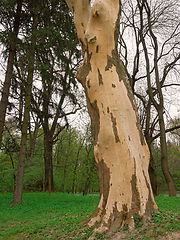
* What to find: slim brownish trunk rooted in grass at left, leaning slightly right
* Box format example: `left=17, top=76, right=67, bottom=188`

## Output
left=11, top=8, right=38, bottom=206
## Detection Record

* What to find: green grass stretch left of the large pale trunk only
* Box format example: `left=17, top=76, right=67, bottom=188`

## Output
left=0, top=193, right=99, bottom=240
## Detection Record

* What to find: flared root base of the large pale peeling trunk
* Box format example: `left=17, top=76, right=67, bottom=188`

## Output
left=81, top=180, right=159, bottom=234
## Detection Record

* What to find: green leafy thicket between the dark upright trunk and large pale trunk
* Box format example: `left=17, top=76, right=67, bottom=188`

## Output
left=53, top=129, right=99, bottom=193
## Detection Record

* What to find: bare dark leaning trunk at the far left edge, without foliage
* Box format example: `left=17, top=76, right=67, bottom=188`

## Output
left=0, top=0, right=22, bottom=148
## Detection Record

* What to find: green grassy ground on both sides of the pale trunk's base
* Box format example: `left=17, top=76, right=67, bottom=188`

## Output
left=0, top=193, right=180, bottom=240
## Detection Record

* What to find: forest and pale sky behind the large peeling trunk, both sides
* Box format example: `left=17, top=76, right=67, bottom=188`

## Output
left=0, top=0, right=180, bottom=198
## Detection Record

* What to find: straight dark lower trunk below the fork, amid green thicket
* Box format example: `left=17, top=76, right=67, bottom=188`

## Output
left=44, top=131, right=55, bottom=193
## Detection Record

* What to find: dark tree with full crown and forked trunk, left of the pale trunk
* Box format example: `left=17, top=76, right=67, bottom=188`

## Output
left=32, top=1, right=81, bottom=192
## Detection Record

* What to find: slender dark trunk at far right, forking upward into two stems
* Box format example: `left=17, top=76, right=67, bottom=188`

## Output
left=138, top=0, right=176, bottom=197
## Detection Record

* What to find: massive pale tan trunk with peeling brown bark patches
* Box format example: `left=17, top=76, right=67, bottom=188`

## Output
left=66, top=0, right=157, bottom=232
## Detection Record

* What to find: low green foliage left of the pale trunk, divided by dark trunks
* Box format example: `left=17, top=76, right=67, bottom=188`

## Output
left=0, top=124, right=99, bottom=194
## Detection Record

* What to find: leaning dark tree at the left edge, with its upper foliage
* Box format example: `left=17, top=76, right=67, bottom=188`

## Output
left=0, top=0, right=23, bottom=147
